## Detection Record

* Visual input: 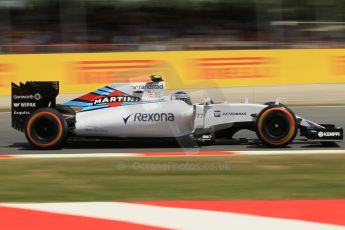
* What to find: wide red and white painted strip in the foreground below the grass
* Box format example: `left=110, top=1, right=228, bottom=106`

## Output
left=0, top=200, right=345, bottom=230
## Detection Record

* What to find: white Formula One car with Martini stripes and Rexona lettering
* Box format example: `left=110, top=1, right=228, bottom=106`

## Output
left=12, top=75, right=343, bottom=149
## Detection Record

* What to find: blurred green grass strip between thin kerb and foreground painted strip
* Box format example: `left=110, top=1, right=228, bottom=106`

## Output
left=0, top=155, right=345, bottom=202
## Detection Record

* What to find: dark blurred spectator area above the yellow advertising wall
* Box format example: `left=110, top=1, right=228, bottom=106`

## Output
left=0, top=0, right=345, bottom=54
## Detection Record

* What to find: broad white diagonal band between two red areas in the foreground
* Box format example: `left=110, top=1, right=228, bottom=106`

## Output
left=1, top=202, right=344, bottom=230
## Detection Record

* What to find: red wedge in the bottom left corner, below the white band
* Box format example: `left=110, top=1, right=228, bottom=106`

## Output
left=0, top=207, right=162, bottom=230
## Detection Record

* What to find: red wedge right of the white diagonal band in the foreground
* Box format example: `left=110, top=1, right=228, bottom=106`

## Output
left=136, top=200, right=345, bottom=226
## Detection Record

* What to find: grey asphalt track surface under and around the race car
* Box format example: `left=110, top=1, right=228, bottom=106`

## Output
left=0, top=106, right=345, bottom=155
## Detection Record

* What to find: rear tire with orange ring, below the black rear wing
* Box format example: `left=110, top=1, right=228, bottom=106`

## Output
left=24, top=108, right=68, bottom=149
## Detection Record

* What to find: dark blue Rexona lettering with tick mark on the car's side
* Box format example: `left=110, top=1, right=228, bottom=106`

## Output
left=122, top=113, right=175, bottom=124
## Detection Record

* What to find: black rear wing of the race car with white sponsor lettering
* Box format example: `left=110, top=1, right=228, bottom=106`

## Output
left=11, top=81, right=59, bottom=131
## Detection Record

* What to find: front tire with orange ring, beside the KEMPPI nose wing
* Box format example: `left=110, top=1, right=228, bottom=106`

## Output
left=255, top=105, right=298, bottom=148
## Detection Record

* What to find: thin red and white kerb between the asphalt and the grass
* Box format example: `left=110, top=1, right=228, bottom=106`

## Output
left=0, top=150, right=345, bottom=159
